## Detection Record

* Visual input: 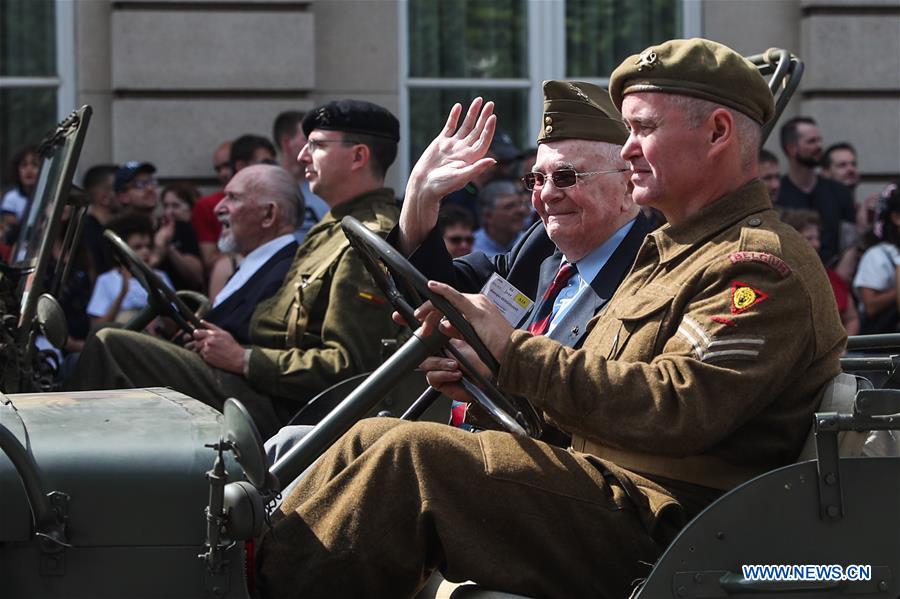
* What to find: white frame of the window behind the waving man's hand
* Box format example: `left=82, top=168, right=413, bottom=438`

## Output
left=397, top=0, right=703, bottom=189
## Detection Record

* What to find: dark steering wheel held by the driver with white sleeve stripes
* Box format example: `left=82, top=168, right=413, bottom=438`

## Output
left=341, top=216, right=543, bottom=437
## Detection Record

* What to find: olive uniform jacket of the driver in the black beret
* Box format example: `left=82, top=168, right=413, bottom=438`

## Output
left=247, top=188, right=400, bottom=418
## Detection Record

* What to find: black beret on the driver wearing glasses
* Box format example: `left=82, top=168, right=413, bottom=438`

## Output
left=301, top=100, right=400, bottom=142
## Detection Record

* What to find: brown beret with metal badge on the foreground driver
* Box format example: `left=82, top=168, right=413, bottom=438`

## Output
left=609, top=38, right=775, bottom=124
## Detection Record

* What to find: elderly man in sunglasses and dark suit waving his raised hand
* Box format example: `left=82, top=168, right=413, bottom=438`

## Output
left=389, top=81, right=652, bottom=434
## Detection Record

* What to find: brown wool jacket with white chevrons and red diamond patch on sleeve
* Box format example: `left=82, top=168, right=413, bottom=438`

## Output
left=500, top=180, right=846, bottom=490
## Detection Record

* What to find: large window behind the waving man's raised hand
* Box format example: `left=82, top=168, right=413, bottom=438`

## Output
left=401, top=0, right=684, bottom=175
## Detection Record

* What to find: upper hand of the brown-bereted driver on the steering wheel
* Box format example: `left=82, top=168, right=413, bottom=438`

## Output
left=415, top=281, right=515, bottom=362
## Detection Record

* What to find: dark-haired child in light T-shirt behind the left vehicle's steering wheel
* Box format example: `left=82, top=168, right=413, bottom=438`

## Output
left=87, top=213, right=172, bottom=328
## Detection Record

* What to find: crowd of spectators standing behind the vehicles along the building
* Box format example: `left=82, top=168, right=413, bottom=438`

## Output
left=0, top=111, right=900, bottom=368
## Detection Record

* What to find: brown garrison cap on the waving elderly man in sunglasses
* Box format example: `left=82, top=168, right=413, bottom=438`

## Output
left=537, top=80, right=628, bottom=146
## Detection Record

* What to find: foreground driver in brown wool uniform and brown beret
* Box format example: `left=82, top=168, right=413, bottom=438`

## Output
left=258, top=39, right=846, bottom=597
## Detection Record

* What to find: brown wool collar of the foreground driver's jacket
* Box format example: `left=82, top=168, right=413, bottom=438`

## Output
left=650, top=179, right=772, bottom=263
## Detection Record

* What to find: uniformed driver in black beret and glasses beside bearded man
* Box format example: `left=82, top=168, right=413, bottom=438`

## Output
left=70, top=100, right=399, bottom=437
